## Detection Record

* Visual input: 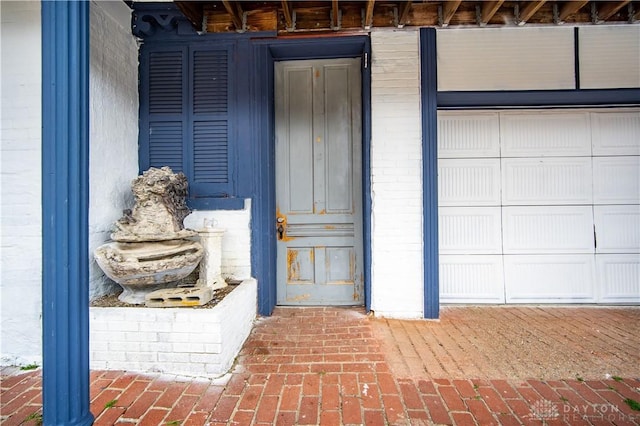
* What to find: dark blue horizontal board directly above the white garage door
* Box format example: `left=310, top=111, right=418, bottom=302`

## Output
left=437, top=88, right=640, bottom=109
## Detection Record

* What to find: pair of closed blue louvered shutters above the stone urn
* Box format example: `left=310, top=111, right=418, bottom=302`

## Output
left=140, top=43, right=244, bottom=209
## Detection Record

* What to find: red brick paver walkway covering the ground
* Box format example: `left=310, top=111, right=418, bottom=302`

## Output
left=0, top=308, right=640, bottom=426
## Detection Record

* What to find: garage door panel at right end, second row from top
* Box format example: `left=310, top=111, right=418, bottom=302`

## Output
left=593, top=156, right=640, bottom=204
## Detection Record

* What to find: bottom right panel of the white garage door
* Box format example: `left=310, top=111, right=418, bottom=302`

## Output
left=596, top=254, right=640, bottom=303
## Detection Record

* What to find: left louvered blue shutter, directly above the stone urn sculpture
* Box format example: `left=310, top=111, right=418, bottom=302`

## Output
left=141, top=49, right=188, bottom=172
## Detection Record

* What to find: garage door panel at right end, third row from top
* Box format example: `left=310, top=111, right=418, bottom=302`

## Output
left=593, top=205, right=640, bottom=253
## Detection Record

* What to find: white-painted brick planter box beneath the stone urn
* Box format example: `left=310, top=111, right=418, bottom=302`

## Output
left=89, top=279, right=258, bottom=377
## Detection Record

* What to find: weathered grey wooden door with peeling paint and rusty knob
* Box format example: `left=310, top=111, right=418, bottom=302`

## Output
left=275, top=59, right=363, bottom=305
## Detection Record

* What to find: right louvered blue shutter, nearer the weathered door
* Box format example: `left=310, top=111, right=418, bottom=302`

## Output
left=190, top=48, right=233, bottom=197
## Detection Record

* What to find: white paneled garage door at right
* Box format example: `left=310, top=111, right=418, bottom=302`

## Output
left=438, top=109, right=640, bottom=303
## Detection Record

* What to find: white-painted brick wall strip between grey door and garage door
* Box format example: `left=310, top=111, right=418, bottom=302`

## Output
left=371, top=30, right=423, bottom=318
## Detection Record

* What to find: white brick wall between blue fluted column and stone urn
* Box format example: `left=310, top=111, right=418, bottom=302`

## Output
left=89, top=1, right=138, bottom=299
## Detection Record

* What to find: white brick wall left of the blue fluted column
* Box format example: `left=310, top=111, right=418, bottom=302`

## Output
left=0, top=1, right=42, bottom=365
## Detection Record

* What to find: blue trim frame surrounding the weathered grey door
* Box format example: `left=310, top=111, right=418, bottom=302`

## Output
left=251, top=36, right=371, bottom=315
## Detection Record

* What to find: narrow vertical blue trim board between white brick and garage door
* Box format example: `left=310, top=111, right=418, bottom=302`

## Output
left=420, top=28, right=440, bottom=319
